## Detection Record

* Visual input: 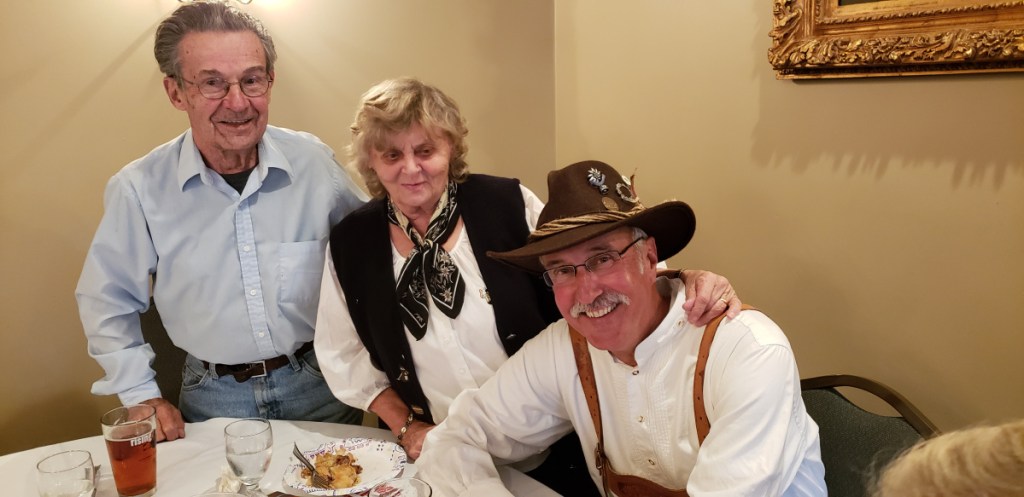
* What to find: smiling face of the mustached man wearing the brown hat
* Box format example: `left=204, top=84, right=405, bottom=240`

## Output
left=541, top=227, right=668, bottom=365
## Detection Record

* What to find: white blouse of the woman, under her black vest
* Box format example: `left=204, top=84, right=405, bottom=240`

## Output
left=313, top=185, right=544, bottom=423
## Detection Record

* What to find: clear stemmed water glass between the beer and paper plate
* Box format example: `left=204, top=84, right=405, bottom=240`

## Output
left=224, top=418, right=273, bottom=496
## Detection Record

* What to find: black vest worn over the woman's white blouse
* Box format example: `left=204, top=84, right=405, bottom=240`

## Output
left=331, top=174, right=560, bottom=423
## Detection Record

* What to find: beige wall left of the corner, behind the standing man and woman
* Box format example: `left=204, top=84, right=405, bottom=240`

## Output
left=0, top=0, right=554, bottom=453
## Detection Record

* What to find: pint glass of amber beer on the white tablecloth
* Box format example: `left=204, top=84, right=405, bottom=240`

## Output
left=100, top=404, right=157, bottom=497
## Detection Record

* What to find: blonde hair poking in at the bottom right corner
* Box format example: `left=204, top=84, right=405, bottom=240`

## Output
left=874, top=419, right=1024, bottom=497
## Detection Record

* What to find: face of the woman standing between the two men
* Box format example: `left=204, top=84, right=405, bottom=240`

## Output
left=370, top=124, right=452, bottom=224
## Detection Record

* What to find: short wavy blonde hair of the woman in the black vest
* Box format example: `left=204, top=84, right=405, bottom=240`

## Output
left=347, top=78, right=469, bottom=198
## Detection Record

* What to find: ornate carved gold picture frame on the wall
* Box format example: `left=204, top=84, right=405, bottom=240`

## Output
left=768, top=0, right=1024, bottom=79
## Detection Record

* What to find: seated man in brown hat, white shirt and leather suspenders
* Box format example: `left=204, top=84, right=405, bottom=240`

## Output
left=417, top=161, right=826, bottom=497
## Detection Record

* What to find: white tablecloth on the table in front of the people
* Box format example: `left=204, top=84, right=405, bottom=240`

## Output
left=0, top=418, right=558, bottom=497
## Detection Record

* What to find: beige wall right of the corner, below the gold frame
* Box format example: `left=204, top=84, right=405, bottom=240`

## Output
left=552, top=0, right=1024, bottom=429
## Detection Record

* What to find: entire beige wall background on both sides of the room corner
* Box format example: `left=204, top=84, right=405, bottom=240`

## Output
left=0, top=0, right=1024, bottom=453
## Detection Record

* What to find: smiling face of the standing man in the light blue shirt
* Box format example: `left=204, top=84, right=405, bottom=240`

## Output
left=164, top=31, right=273, bottom=172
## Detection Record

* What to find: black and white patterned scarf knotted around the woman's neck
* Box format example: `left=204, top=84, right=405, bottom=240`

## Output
left=387, top=181, right=466, bottom=340
